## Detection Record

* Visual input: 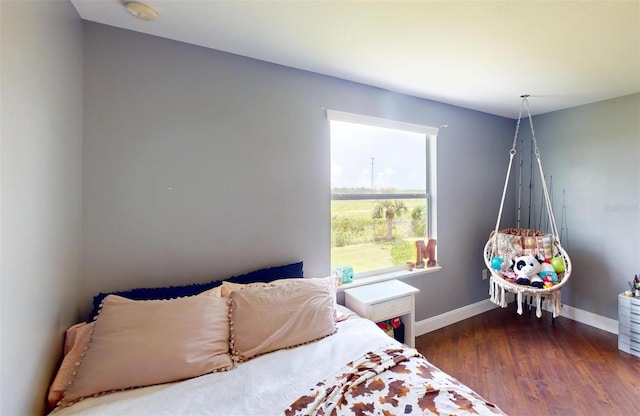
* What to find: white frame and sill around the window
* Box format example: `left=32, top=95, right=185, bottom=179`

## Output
left=327, top=109, right=440, bottom=286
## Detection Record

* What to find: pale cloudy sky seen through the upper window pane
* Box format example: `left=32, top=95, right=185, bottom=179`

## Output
left=331, top=120, right=427, bottom=190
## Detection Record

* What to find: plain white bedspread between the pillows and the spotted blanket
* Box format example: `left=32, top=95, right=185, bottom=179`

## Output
left=52, top=318, right=398, bottom=416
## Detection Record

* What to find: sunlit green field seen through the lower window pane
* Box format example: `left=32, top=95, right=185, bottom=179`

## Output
left=331, top=199, right=425, bottom=273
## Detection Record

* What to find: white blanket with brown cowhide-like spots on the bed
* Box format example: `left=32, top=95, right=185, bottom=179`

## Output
left=284, top=345, right=504, bottom=416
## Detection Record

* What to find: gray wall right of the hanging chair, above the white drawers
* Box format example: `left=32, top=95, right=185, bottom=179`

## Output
left=534, top=94, right=640, bottom=319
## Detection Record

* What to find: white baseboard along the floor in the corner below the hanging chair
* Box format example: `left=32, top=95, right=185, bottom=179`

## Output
left=414, top=299, right=618, bottom=336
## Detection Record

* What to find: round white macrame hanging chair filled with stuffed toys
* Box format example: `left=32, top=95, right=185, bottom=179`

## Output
left=484, top=95, right=571, bottom=319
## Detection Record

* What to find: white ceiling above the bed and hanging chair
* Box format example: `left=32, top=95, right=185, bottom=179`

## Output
left=71, top=0, right=640, bottom=118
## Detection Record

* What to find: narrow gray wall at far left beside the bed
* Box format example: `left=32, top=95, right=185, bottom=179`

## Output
left=0, top=1, right=82, bottom=415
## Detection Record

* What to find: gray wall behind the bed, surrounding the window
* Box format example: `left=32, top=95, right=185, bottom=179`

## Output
left=82, top=23, right=515, bottom=320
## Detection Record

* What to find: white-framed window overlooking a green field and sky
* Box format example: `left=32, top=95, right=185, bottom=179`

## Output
left=327, top=110, right=438, bottom=277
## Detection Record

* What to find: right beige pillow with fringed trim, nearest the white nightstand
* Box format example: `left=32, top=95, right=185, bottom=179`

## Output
left=230, top=278, right=336, bottom=362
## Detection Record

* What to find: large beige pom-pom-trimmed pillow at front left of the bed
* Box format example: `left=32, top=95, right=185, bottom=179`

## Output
left=62, top=295, right=232, bottom=406
